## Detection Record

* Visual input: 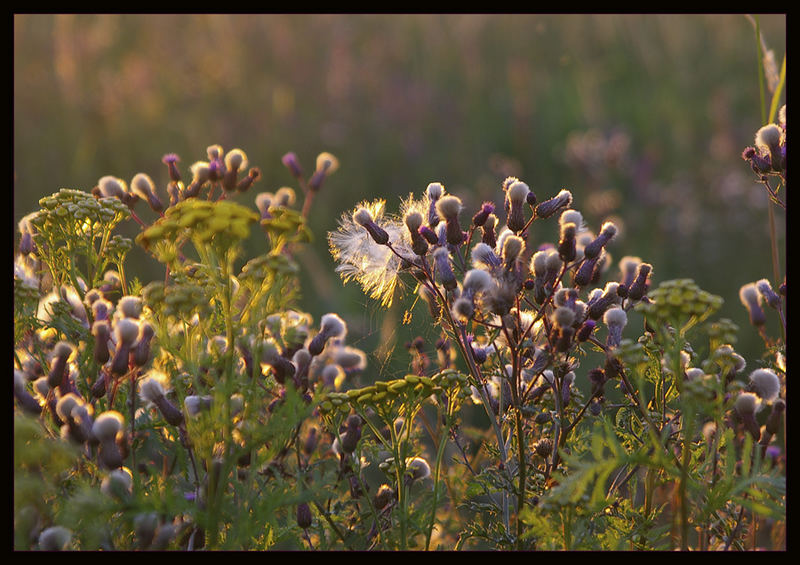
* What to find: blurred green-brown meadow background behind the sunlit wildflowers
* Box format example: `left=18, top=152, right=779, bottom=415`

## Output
left=14, top=14, right=786, bottom=372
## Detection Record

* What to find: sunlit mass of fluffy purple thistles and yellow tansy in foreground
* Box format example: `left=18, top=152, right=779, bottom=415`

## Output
left=13, top=24, right=786, bottom=550
